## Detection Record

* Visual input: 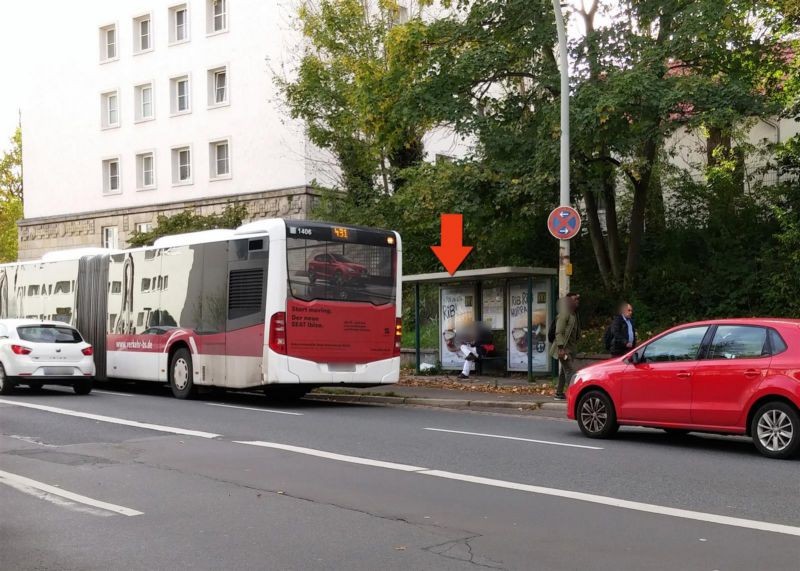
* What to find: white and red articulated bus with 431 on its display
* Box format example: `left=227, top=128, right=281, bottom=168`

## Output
left=0, top=219, right=402, bottom=398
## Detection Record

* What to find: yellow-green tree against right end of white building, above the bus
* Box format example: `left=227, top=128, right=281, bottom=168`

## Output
left=277, top=0, right=434, bottom=205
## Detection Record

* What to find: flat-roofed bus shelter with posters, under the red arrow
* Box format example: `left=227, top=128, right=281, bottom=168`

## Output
left=403, top=267, right=558, bottom=380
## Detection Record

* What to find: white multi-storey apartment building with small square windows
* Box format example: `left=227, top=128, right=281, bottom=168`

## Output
left=19, top=0, right=472, bottom=259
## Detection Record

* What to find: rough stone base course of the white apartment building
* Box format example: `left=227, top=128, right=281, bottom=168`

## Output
left=18, top=187, right=317, bottom=261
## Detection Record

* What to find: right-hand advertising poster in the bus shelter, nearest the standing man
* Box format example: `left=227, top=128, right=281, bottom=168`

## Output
left=508, top=280, right=550, bottom=373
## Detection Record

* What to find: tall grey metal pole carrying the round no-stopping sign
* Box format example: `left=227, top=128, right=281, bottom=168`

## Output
left=553, top=0, right=570, bottom=298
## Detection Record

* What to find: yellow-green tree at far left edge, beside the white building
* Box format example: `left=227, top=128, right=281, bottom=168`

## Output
left=0, top=128, right=23, bottom=262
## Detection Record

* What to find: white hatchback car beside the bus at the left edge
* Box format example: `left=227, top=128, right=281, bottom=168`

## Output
left=0, top=319, right=95, bottom=395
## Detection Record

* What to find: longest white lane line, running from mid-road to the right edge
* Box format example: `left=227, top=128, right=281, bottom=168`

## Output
left=234, top=441, right=800, bottom=537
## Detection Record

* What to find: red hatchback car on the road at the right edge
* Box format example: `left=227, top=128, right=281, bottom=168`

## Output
left=567, top=319, right=800, bottom=458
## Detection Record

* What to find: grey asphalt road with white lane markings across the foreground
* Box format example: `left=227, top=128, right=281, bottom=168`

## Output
left=0, top=387, right=800, bottom=571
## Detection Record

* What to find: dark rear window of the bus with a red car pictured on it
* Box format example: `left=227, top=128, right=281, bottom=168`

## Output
left=286, top=236, right=397, bottom=305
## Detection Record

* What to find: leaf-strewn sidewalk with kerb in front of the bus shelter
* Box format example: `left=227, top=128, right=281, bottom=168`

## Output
left=307, top=373, right=566, bottom=412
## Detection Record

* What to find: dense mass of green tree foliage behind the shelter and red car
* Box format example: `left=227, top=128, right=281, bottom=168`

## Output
left=283, top=0, right=800, bottom=334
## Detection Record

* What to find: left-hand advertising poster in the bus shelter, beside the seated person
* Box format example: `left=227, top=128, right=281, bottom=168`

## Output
left=439, top=286, right=475, bottom=369
